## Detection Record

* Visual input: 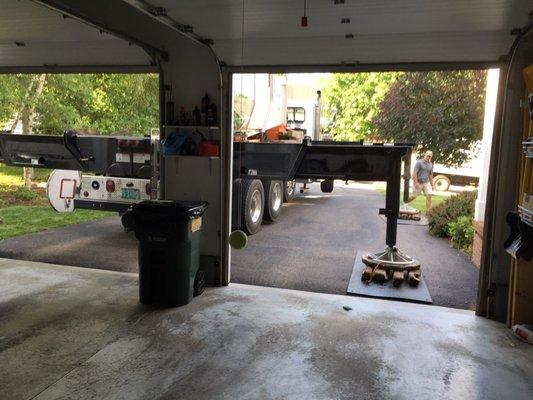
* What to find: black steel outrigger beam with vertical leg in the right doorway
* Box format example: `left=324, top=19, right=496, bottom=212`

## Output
left=233, top=140, right=412, bottom=247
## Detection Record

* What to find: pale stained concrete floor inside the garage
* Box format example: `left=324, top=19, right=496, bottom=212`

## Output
left=0, top=259, right=533, bottom=400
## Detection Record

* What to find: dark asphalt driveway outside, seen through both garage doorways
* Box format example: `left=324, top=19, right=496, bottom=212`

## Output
left=0, top=183, right=478, bottom=309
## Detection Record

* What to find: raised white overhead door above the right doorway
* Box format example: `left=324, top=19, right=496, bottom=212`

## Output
left=147, top=0, right=533, bottom=66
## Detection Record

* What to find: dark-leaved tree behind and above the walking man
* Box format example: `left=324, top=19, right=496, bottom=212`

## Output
left=371, top=71, right=486, bottom=166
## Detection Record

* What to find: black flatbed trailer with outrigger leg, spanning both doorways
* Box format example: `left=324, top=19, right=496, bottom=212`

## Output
left=0, top=131, right=412, bottom=245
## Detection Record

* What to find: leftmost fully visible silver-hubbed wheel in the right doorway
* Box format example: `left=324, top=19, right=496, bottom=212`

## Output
left=242, top=179, right=265, bottom=235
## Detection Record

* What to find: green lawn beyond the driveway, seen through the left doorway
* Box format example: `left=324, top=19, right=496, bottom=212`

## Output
left=0, top=164, right=115, bottom=240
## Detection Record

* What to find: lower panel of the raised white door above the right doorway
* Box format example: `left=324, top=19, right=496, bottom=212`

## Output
left=215, top=32, right=513, bottom=65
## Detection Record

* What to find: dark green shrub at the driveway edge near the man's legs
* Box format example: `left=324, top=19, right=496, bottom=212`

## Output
left=427, top=191, right=477, bottom=237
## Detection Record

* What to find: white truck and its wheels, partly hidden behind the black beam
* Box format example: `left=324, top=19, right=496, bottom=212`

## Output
left=233, top=74, right=335, bottom=235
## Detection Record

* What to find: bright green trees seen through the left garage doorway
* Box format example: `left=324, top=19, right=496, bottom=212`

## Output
left=0, top=74, right=159, bottom=135
